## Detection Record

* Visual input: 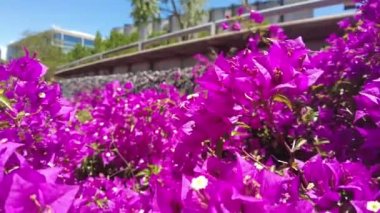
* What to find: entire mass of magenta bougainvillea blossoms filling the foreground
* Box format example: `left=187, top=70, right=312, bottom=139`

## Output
left=0, top=0, right=380, bottom=212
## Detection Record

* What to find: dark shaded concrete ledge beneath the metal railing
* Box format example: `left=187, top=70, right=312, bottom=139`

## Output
left=56, top=13, right=353, bottom=78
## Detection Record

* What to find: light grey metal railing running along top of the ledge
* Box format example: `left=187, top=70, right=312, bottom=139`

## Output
left=57, top=0, right=345, bottom=70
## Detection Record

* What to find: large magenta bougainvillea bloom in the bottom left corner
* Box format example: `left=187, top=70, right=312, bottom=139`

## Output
left=2, top=166, right=79, bottom=212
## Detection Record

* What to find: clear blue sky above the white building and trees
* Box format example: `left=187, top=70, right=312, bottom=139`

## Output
left=0, top=0, right=344, bottom=57
